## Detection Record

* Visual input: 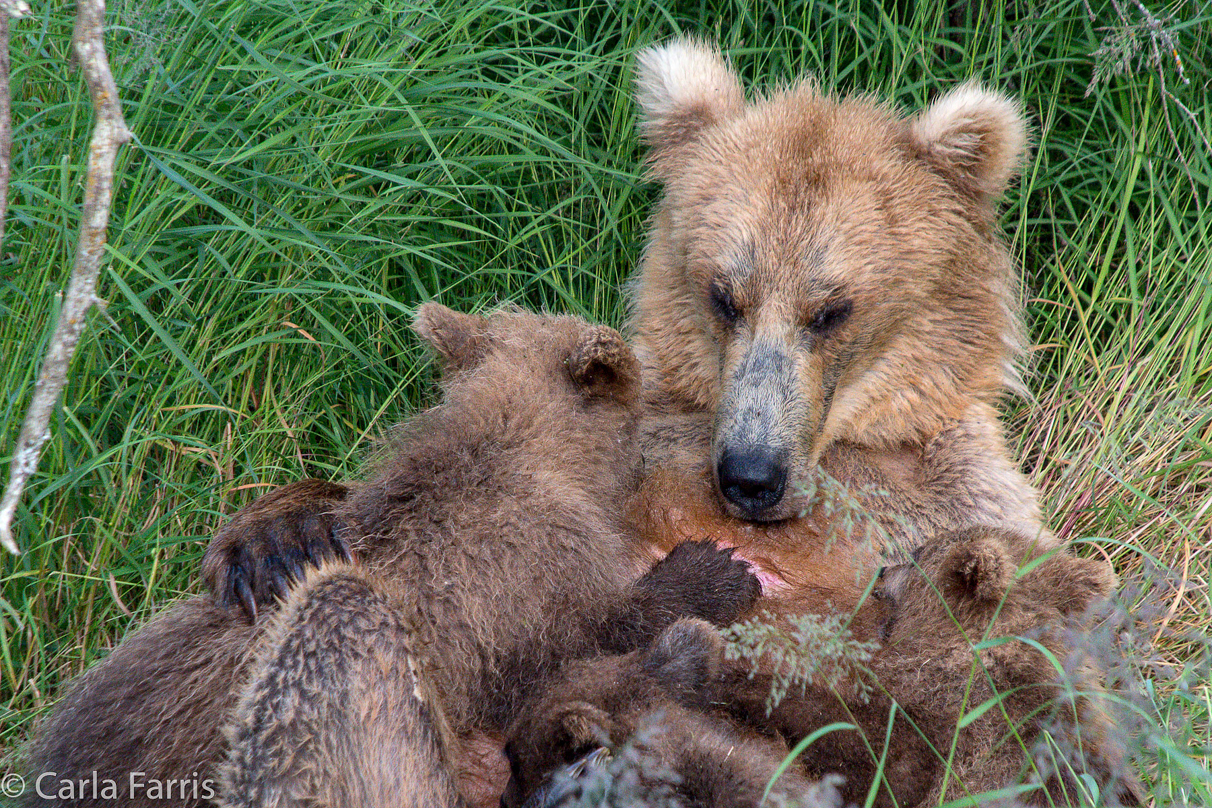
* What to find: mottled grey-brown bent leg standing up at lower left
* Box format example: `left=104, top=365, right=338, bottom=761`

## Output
left=218, top=565, right=464, bottom=808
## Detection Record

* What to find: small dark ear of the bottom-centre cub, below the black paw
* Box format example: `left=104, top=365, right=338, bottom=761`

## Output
left=641, top=618, right=724, bottom=706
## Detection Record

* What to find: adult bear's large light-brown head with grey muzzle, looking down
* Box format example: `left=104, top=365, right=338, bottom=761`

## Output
left=631, top=40, right=1027, bottom=521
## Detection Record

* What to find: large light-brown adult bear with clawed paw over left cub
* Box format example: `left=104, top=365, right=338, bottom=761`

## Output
left=204, top=39, right=1052, bottom=625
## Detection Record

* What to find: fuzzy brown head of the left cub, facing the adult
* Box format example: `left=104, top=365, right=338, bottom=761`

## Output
left=413, top=303, right=640, bottom=482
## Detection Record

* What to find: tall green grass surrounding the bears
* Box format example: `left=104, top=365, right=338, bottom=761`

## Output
left=0, top=0, right=1212, bottom=803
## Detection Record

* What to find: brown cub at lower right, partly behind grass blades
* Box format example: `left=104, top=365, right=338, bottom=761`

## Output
left=871, top=526, right=1143, bottom=804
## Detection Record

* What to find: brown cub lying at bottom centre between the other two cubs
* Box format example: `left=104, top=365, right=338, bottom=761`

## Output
left=502, top=620, right=841, bottom=808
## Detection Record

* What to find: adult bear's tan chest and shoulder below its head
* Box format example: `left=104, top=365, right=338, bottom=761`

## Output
left=628, top=414, right=1037, bottom=613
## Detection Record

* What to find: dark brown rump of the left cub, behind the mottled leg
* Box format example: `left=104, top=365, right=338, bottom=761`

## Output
left=23, top=596, right=257, bottom=808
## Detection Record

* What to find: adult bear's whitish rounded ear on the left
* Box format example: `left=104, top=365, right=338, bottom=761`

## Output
left=635, top=36, right=745, bottom=176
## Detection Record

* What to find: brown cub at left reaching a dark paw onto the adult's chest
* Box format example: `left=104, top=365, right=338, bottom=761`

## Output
left=21, top=304, right=759, bottom=806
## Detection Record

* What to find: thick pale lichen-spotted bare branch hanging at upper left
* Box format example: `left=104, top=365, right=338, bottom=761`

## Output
left=0, top=0, right=131, bottom=552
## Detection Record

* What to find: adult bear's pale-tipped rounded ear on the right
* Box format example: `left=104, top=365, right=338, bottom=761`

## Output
left=910, top=81, right=1027, bottom=205
